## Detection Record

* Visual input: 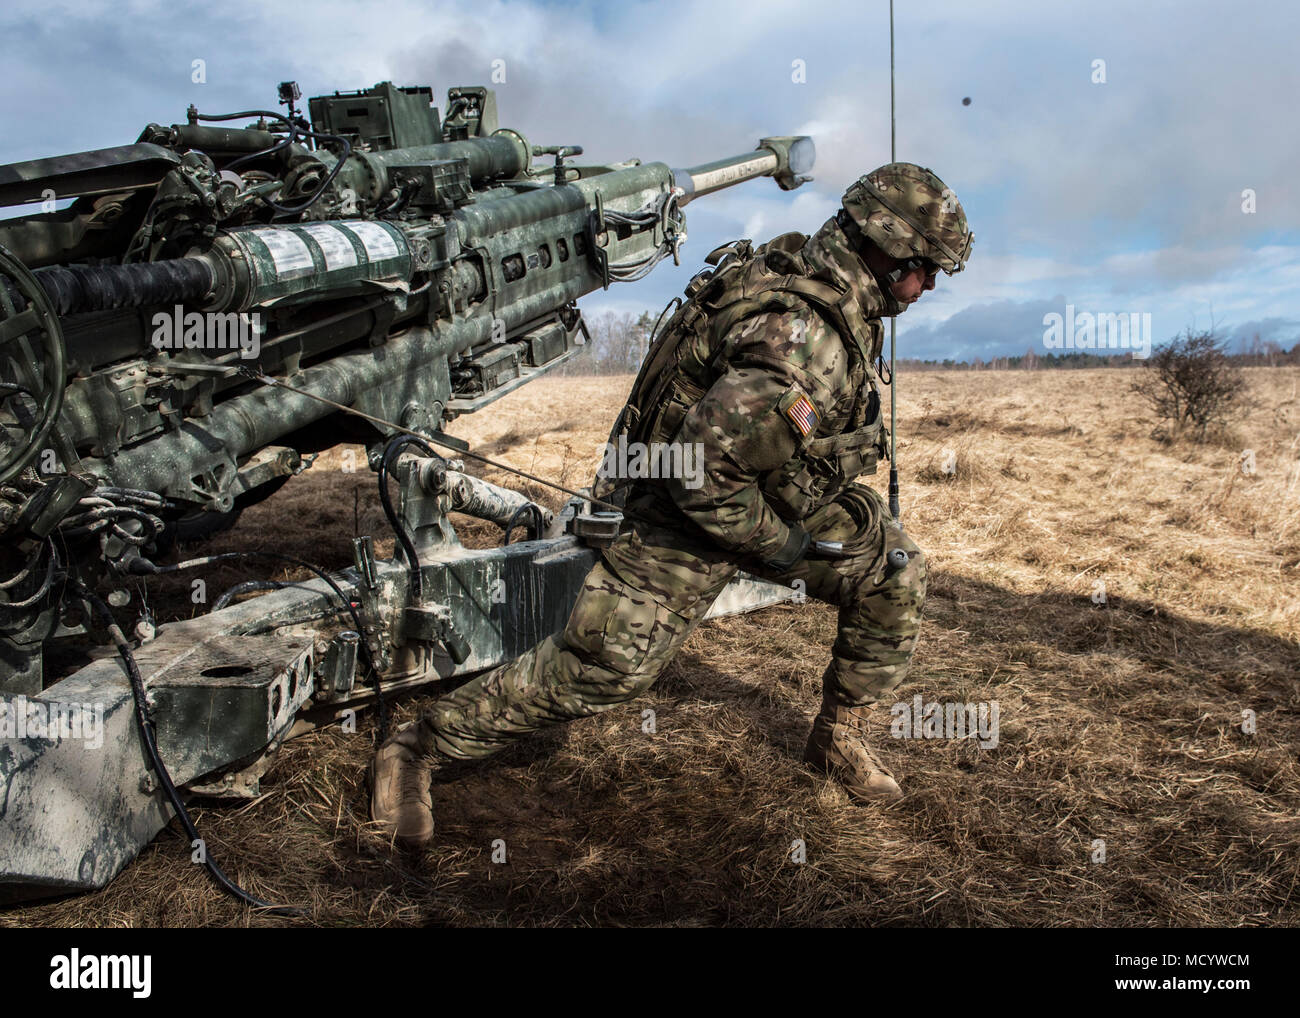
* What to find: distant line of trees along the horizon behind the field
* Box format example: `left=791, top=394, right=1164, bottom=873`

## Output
left=559, top=311, right=1300, bottom=374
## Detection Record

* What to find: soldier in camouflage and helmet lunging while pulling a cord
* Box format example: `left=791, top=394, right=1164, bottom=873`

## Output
left=371, top=163, right=971, bottom=846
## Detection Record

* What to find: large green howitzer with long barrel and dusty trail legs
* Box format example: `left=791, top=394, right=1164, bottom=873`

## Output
left=0, top=82, right=813, bottom=900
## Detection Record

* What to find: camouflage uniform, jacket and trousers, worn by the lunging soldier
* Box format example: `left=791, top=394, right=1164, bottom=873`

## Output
left=379, top=164, right=969, bottom=821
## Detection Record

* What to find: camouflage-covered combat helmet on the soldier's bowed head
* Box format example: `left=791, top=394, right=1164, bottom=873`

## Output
left=841, top=163, right=975, bottom=276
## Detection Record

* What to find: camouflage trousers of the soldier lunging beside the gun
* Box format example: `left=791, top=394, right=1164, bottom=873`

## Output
left=416, top=486, right=926, bottom=759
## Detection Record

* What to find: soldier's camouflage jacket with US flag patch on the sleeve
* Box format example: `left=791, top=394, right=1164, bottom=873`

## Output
left=611, top=218, right=900, bottom=559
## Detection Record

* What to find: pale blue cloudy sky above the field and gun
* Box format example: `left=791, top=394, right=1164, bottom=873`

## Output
left=0, top=0, right=1300, bottom=359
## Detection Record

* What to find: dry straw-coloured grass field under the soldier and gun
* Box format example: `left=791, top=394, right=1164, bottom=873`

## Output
left=0, top=368, right=1300, bottom=927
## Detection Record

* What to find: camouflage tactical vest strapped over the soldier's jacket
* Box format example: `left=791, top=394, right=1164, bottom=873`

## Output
left=593, top=233, right=887, bottom=521
